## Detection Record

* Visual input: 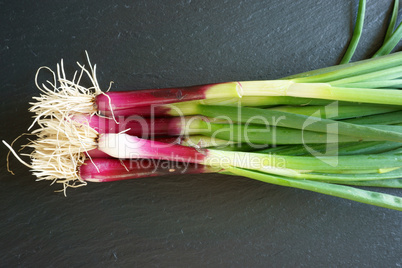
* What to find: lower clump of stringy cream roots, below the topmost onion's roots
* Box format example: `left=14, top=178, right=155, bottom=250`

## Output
left=3, top=111, right=99, bottom=194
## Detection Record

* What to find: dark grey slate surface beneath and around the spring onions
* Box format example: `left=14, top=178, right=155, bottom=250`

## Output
left=0, top=0, right=402, bottom=267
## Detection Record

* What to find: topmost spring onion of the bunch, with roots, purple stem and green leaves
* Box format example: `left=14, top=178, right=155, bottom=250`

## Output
left=31, top=49, right=402, bottom=122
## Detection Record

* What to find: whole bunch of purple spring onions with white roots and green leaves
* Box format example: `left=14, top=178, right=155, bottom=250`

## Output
left=2, top=1, right=402, bottom=210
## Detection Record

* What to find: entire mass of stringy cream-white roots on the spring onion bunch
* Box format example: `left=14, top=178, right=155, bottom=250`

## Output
left=3, top=52, right=119, bottom=194
